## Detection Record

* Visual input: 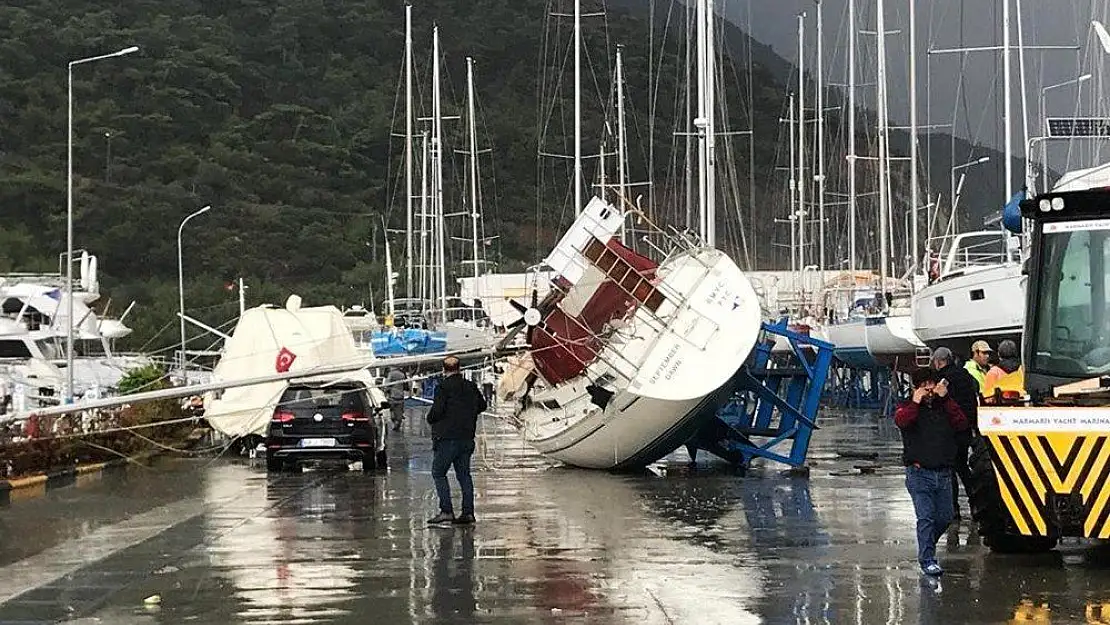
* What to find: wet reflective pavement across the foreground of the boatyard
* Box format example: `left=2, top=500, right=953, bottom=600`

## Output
left=0, top=408, right=1110, bottom=625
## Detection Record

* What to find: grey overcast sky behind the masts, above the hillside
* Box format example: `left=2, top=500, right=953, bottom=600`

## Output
left=716, top=0, right=1110, bottom=185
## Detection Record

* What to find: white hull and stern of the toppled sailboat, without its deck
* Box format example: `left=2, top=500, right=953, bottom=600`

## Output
left=519, top=249, right=761, bottom=470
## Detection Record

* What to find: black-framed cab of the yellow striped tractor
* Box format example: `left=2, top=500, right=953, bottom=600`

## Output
left=1021, top=188, right=1110, bottom=404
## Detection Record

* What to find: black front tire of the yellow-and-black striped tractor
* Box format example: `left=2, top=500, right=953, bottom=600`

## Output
left=968, top=435, right=1057, bottom=554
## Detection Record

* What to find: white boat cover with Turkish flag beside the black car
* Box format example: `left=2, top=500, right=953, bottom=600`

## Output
left=204, top=295, right=372, bottom=436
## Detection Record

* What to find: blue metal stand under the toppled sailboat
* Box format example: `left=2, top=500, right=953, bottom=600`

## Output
left=686, top=320, right=833, bottom=467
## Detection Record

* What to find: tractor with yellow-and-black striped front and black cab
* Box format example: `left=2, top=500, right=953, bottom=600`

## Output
left=968, top=188, right=1110, bottom=553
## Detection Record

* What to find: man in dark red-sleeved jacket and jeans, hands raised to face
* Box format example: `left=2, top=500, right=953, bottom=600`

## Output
left=895, top=369, right=968, bottom=576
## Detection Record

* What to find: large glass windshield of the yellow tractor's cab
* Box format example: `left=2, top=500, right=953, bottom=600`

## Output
left=1031, top=219, right=1110, bottom=377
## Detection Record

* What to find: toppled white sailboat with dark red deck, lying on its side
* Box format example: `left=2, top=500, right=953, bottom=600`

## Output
left=502, top=198, right=761, bottom=468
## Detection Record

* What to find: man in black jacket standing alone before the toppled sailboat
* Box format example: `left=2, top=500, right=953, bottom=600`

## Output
left=427, top=356, right=487, bottom=525
